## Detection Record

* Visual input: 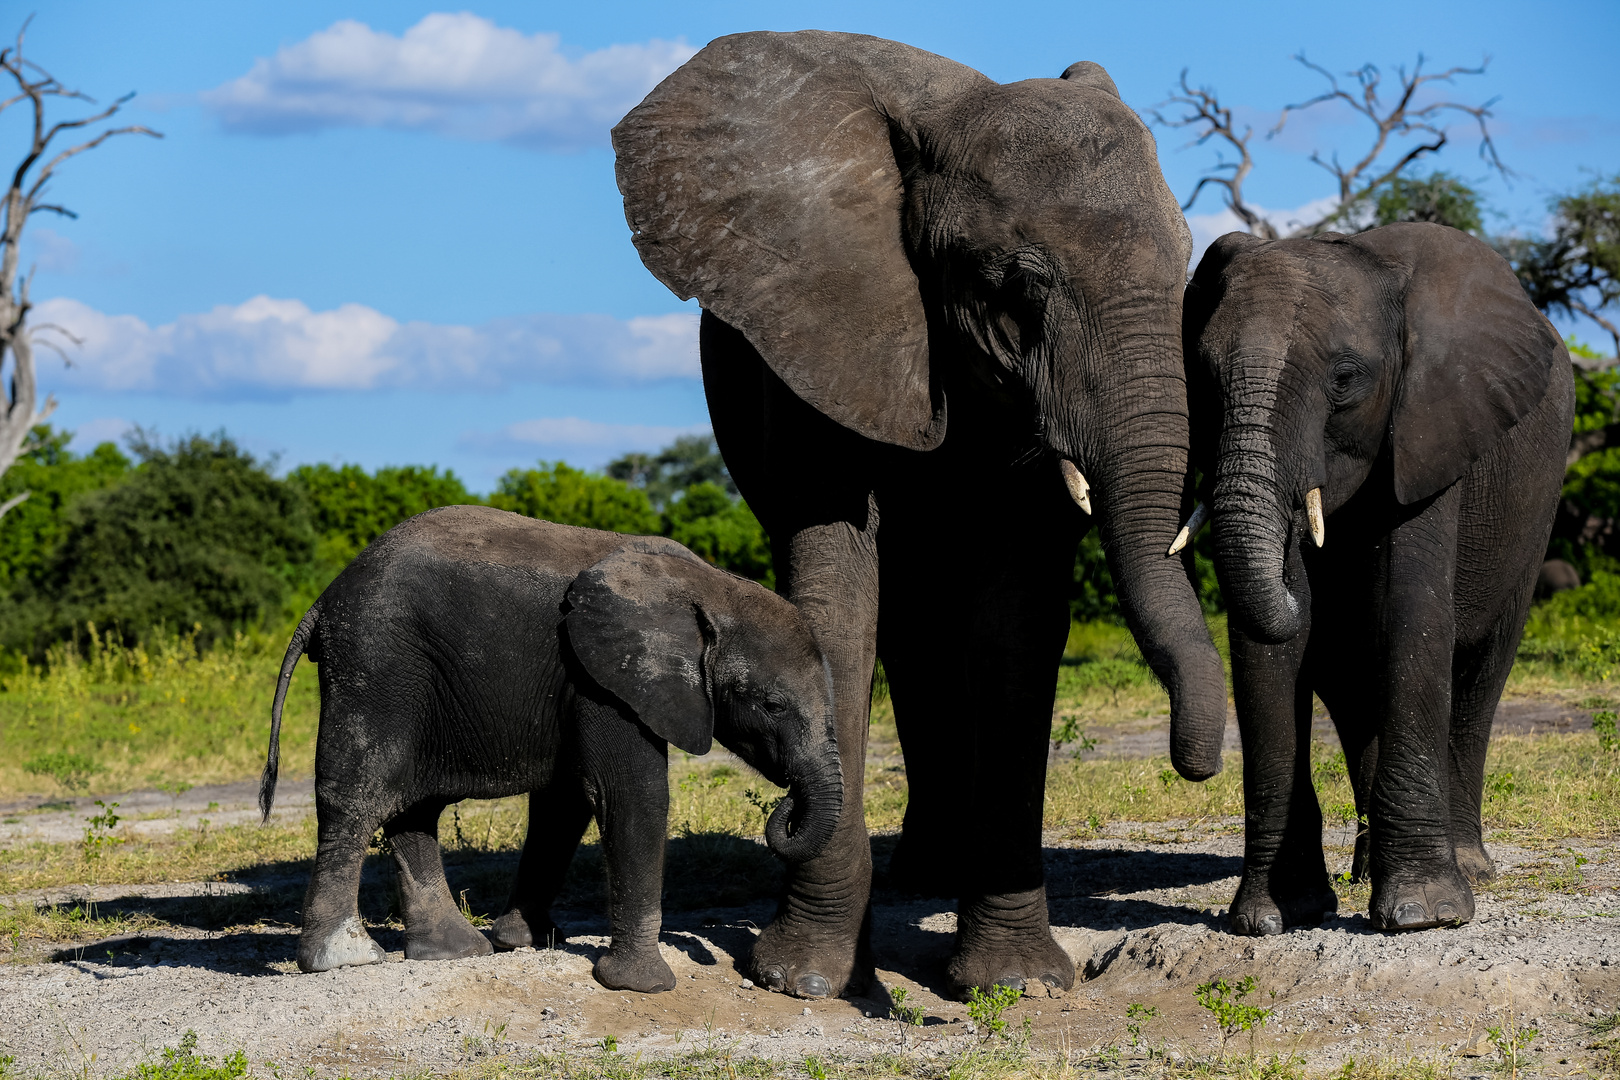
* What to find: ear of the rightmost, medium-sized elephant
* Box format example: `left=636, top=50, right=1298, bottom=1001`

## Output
left=1346, top=223, right=1568, bottom=504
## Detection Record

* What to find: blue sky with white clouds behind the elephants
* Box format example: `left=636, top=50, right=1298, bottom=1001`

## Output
left=15, top=0, right=1620, bottom=491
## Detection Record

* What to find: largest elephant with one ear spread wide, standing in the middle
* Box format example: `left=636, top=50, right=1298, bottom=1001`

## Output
left=614, top=31, right=1225, bottom=997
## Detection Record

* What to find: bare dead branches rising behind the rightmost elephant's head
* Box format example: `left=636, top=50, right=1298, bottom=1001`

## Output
left=1147, top=53, right=1511, bottom=240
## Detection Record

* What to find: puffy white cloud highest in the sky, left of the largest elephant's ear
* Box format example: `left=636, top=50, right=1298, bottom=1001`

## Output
left=203, top=11, right=695, bottom=149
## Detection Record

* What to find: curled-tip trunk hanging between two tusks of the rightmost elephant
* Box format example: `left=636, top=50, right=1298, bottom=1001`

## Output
left=1212, top=358, right=1301, bottom=644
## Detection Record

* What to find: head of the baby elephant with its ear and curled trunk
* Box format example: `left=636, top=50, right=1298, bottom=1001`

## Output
left=564, top=546, right=844, bottom=861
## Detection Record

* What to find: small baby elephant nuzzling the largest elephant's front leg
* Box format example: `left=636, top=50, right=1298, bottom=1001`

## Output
left=259, top=507, right=844, bottom=993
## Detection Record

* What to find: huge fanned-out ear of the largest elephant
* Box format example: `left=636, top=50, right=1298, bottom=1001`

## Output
left=612, top=31, right=990, bottom=450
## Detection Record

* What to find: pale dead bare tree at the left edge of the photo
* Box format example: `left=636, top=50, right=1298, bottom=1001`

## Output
left=0, top=21, right=164, bottom=517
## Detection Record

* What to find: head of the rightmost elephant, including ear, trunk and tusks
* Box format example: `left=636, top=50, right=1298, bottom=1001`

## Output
left=1186, top=223, right=1565, bottom=643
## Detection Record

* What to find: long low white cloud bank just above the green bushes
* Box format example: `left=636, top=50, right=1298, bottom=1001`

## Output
left=34, top=296, right=698, bottom=398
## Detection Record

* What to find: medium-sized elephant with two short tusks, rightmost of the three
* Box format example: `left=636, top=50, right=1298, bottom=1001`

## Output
left=1186, top=223, right=1575, bottom=934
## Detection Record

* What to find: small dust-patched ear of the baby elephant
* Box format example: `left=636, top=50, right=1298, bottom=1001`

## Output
left=564, top=551, right=714, bottom=755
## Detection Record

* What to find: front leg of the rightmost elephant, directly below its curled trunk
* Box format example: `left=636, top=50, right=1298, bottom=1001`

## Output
left=1226, top=608, right=1338, bottom=936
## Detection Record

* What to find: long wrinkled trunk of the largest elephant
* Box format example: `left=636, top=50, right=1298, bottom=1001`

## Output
left=1094, top=337, right=1226, bottom=780
